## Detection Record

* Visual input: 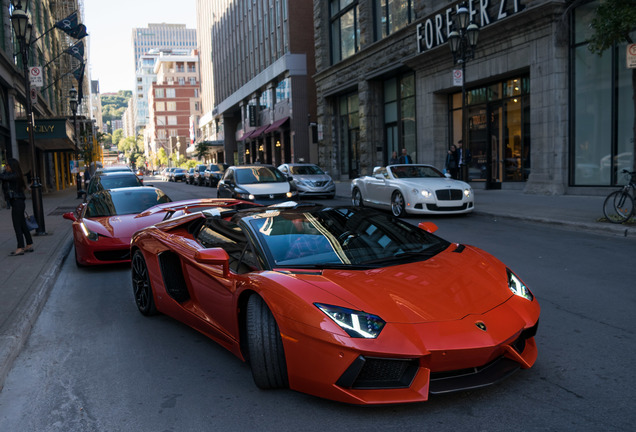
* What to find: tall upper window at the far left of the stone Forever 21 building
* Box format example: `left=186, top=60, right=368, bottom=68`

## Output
left=329, top=0, right=360, bottom=64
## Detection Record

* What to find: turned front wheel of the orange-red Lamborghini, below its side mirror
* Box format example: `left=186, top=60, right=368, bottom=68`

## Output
left=246, top=295, right=289, bottom=389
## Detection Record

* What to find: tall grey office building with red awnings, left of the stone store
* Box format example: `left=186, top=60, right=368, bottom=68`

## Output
left=197, top=0, right=317, bottom=164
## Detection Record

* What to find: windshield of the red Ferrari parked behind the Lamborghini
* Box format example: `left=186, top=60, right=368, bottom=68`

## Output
left=84, top=188, right=172, bottom=218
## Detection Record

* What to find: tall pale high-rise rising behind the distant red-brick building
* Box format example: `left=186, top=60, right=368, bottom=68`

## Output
left=132, top=23, right=197, bottom=131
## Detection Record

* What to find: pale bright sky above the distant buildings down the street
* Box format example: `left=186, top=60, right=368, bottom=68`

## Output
left=82, top=0, right=196, bottom=93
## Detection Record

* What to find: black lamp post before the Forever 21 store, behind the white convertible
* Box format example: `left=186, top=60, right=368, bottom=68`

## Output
left=448, top=5, right=479, bottom=181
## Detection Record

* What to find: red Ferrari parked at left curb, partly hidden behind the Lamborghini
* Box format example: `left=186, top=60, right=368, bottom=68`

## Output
left=63, top=187, right=253, bottom=267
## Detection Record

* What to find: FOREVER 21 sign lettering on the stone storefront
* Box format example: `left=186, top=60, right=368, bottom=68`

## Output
left=417, top=0, right=524, bottom=53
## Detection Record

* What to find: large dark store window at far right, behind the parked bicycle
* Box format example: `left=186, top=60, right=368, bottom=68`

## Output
left=570, top=1, right=636, bottom=186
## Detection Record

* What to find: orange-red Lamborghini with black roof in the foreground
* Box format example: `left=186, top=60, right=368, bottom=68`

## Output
left=131, top=204, right=540, bottom=404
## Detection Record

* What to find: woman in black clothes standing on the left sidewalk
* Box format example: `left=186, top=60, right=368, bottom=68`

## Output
left=0, top=158, right=33, bottom=256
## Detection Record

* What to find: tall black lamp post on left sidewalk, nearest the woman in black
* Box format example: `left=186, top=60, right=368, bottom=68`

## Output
left=11, top=2, right=46, bottom=235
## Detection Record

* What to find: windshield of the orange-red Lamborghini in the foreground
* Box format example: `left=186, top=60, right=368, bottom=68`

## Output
left=248, top=207, right=449, bottom=268
